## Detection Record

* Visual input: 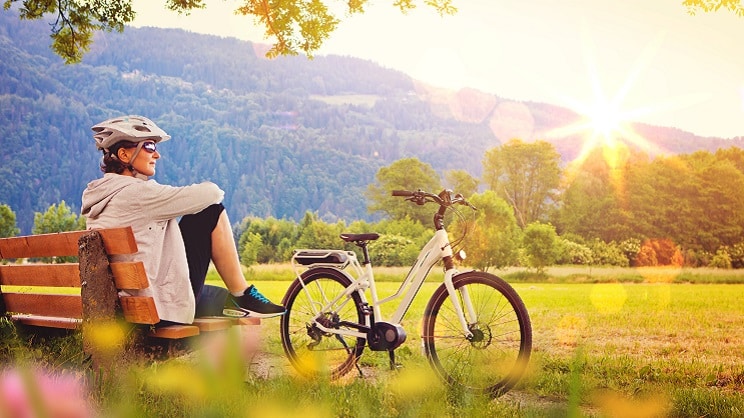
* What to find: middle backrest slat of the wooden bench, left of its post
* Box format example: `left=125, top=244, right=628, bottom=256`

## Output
left=0, top=263, right=80, bottom=287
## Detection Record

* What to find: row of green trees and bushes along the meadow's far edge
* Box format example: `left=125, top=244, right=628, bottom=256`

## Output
left=8, top=141, right=744, bottom=271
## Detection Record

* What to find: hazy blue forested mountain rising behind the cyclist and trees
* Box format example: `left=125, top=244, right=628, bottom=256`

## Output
left=0, top=11, right=740, bottom=233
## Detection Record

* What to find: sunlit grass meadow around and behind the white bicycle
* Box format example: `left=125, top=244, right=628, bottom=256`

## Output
left=0, top=266, right=744, bottom=418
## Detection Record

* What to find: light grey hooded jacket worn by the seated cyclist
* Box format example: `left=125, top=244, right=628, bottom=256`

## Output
left=82, top=173, right=225, bottom=324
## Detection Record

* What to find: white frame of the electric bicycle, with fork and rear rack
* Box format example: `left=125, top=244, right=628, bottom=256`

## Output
left=292, top=228, right=477, bottom=338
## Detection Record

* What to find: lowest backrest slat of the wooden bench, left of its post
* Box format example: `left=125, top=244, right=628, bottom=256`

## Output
left=3, top=293, right=83, bottom=318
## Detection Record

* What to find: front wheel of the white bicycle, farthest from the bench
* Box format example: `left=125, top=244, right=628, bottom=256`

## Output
left=422, top=271, right=532, bottom=397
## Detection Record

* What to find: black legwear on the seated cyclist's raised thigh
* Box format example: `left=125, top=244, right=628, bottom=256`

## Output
left=178, top=203, right=225, bottom=300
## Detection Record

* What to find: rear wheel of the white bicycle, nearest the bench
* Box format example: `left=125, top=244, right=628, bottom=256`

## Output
left=280, top=268, right=366, bottom=380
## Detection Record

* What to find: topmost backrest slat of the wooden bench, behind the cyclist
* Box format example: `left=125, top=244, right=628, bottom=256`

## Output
left=0, top=227, right=137, bottom=258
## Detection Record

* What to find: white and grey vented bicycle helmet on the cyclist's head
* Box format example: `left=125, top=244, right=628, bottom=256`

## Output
left=91, top=115, right=170, bottom=151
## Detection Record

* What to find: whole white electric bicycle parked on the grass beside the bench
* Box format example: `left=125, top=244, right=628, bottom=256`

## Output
left=281, top=190, right=532, bottom=397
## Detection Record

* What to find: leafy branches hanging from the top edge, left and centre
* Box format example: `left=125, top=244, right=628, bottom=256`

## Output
left=3, top=0, right=457, bottom=63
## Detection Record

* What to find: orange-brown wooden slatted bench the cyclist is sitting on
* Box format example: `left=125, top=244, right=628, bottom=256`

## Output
left=0, top=227, right=260, bottom=364
